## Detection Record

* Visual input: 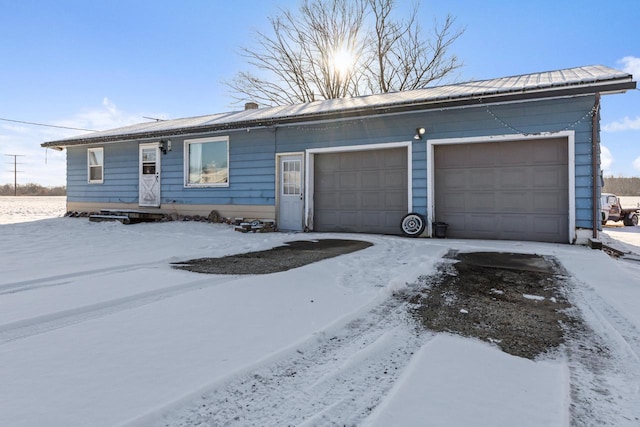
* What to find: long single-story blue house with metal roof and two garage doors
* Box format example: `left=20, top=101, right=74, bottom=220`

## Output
left=42, top=65, right=636, bottom=243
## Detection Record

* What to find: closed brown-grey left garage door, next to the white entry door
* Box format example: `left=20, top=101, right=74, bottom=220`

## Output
left=313, top=148, right=407, bottom=234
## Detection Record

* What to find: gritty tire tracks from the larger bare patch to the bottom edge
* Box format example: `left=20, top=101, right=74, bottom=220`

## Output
left=146, top=290, right=433, bottom=427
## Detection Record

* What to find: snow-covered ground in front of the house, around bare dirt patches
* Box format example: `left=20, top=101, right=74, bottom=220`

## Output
left=0, top=201, right=640, bottom=427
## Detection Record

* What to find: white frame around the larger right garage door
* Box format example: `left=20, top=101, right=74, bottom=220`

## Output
left=427, top=130, right=576, bottom=243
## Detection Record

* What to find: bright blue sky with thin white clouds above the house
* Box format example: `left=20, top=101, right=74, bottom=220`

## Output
left=0, top=0, right=640, bottom=186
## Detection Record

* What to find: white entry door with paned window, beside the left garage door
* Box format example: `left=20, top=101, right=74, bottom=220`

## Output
left=278, top=154, right=304, bottom=231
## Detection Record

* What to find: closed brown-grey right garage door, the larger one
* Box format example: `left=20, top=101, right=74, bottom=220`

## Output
left=434, top=138, right=569, bottom=243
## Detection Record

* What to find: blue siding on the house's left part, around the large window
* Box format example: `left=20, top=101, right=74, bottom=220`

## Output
left=67, top=130, right=275, bottom=205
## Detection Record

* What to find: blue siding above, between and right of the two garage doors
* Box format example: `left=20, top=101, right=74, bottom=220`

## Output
left=270, top=96, right=594, bottom=224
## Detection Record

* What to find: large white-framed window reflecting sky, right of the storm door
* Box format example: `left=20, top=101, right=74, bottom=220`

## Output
left=184, top=137, right=229, bottom=187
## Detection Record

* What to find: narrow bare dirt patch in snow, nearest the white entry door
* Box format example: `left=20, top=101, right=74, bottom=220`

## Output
left=173, top=239, right=373, bottom=274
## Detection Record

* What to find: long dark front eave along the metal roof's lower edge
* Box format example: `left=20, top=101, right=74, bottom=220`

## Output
left=41, top=76, right=636, bottom=150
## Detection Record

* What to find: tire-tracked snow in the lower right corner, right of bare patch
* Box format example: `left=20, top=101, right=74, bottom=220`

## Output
left=566, top=283, right=640, bottom=426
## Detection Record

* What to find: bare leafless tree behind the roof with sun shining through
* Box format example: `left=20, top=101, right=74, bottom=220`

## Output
left=227, top=0, right=463, bottom=105
